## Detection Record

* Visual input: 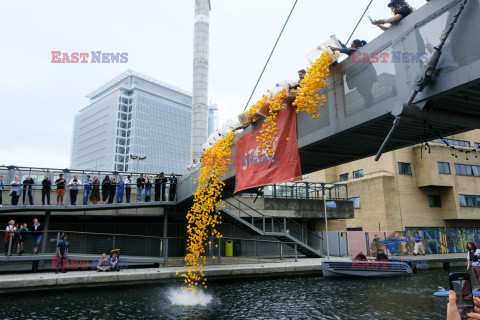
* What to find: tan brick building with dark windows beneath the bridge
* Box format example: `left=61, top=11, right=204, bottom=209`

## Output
left=306, top=130, right=480, bottom=231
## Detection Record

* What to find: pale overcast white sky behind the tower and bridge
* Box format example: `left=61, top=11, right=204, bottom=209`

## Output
left=0, top=0, right=425, bottom=168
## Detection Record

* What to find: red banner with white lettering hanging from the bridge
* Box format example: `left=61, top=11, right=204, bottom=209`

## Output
left=235, top=105, right=302, bottom=193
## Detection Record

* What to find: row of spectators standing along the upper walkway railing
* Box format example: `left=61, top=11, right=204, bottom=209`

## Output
left=0, top=172, right=178, bottom=207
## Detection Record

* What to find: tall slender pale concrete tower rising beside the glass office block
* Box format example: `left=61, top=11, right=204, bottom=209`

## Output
left=191, top=0, right=210, bottom=159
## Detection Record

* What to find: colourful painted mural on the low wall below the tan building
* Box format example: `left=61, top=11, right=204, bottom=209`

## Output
left=347, top=230, right=480, bottom=257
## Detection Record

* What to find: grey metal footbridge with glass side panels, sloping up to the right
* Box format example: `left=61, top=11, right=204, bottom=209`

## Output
left=177, top=0, right=480, bottom=202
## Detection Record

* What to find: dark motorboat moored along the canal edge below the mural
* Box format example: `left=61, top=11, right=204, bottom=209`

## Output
left=322, top=259, right=413, bottom=278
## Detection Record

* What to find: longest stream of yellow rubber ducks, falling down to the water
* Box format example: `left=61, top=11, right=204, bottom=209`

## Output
left=182, top=132, right=235, bottom=294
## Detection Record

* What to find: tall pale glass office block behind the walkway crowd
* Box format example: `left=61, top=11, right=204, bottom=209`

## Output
left=71, top=70, right=216, bottom=174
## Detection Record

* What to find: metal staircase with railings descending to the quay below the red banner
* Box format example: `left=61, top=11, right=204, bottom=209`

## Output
left=220, top=198, right=323, bottom=257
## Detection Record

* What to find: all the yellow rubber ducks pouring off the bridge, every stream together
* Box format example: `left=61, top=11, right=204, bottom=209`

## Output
left=182, top=52, right=333, bottom=294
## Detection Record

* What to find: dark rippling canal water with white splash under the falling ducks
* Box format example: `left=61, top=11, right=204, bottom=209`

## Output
left=0, top=268, right=462, bottom=320
